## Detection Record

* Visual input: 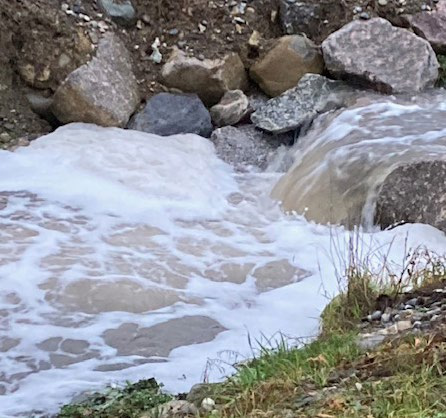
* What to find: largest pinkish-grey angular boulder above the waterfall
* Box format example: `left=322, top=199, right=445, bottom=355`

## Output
left=322, top=18, right=438, bottom=94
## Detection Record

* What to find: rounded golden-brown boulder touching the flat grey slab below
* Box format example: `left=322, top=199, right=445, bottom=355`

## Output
left=250, top=35, right=324, bottom=97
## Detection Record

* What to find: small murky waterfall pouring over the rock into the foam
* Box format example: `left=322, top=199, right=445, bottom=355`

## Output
left=272, top=91, right=446, bottom=227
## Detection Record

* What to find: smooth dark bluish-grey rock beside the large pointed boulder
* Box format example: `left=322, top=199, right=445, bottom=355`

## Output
left=128, top=93, right=212, bottom=137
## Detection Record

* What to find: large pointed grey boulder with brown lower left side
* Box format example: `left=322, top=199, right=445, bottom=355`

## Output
left=51, top=32, right=139, bottom=127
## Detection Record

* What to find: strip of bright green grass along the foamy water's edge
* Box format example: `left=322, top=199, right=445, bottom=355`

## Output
left=213, top=333, right=361, bottom=417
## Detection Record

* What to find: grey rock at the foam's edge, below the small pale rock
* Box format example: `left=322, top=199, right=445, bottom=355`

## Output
left=211, top=125, right=293, bottom=171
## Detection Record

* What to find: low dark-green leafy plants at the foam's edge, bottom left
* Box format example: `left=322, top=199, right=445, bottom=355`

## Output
left=58, top=379, right=172, bottom=418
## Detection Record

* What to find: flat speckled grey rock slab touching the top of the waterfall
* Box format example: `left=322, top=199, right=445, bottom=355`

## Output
left=251, top=74, right=362, bottom=134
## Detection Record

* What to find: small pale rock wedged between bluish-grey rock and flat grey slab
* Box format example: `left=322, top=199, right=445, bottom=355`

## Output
left=210, top=90, right=249, bottom=127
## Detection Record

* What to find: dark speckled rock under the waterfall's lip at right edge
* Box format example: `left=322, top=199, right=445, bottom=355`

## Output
left=375, top=161, right=446, bottom=232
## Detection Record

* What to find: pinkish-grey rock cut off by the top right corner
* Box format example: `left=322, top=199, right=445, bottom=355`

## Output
left=405, top=0, right=446, bottom=54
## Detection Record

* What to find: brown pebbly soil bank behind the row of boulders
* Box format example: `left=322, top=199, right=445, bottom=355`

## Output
left=0, top=0, right=433, bottom=148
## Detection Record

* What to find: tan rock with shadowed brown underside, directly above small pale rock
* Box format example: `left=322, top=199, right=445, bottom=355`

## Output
left=161, top=50, right=248, bottom=106
